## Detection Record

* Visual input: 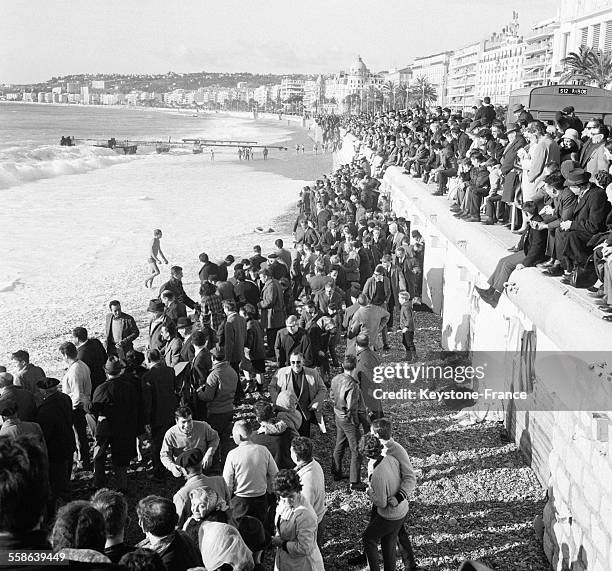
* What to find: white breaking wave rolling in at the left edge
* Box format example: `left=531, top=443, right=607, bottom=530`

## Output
left=0, top=145, right=139, bottom=189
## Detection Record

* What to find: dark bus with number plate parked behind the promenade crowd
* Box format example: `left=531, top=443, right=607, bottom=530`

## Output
left=506, top=85, right=612, bottom=125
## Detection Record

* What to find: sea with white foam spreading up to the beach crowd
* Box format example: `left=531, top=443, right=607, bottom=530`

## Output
left=0, top=104, right=322, bottom=376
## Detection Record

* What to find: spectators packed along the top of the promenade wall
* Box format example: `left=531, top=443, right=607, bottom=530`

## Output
left=342, top=97, right=612, bottom=312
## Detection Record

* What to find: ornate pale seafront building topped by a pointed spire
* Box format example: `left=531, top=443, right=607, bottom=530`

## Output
left=478, top=17, right=525, bottom=105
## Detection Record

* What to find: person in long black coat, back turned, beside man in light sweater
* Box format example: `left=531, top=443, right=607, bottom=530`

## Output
left=36, top=378, right=76, bottom=510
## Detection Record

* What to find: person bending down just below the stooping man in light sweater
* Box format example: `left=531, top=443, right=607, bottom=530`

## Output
left=172, top=450, right=232, bottom=528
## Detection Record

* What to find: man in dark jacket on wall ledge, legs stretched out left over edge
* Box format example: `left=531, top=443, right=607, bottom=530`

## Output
left=474, top=201, right=548, bottom=307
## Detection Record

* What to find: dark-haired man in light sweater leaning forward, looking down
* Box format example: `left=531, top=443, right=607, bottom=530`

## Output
left=160, top=406, right=219, bottom=478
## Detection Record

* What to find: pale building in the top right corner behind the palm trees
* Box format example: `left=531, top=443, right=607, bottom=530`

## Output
left=552, top=0, right=612, bottom=82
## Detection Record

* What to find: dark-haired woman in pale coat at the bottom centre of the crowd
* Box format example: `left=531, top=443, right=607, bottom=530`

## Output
left=272, top=470, right=325, bottom=571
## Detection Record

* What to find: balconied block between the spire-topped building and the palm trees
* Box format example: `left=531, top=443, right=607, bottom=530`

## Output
left=523, top=17, right=559, bottom=87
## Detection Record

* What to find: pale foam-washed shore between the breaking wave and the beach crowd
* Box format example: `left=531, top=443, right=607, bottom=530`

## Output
left=0, top=112, right=332, bottom=376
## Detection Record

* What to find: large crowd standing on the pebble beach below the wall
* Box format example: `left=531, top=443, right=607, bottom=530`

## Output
left=0, top=144, right=442, bottom=571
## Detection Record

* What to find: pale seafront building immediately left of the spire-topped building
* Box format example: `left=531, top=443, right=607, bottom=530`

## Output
left=446, top=42, right=483, bottom=111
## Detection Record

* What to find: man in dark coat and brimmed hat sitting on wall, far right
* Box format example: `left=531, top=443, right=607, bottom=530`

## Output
left=555, top=169, right=610, bottom=283
